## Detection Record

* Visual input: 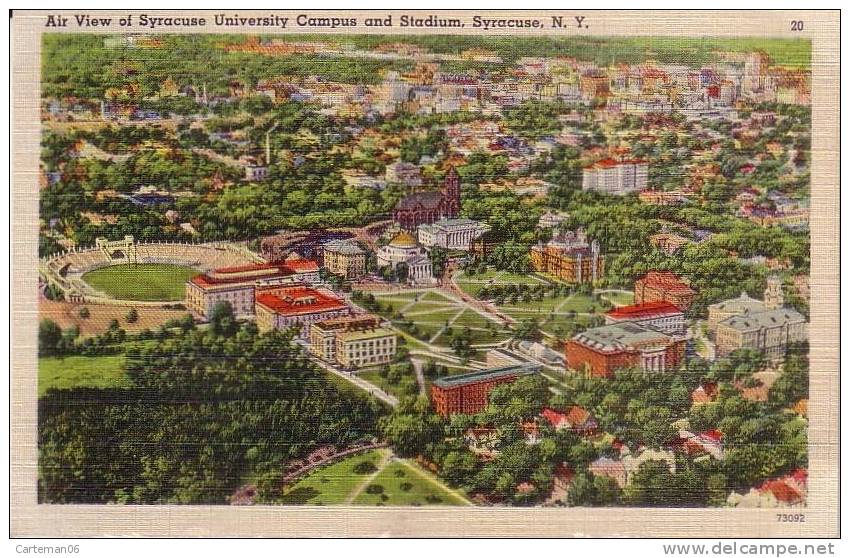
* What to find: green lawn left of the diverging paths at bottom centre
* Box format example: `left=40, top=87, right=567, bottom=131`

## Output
left=277, top=450, right=388, bottom=506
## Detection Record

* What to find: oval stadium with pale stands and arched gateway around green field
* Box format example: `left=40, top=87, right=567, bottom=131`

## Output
left=39, top=236, right=265, bottom=306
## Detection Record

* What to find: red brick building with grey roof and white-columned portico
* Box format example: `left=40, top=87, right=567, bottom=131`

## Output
left=565, top=322, right=685, bottom=377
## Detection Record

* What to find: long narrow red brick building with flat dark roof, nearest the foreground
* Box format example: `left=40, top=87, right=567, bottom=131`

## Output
left=431, top=364, right=540, bottom=417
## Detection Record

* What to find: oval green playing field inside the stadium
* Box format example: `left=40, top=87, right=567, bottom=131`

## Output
left=83, top=264, right=198, bottom=301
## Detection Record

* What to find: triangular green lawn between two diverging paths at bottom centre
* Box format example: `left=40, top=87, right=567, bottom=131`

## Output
left=354, top=461, right=466, bottom=506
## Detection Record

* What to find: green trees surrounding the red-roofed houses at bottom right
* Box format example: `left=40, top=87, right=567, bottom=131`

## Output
left=381, top=346, right=808, bottom=507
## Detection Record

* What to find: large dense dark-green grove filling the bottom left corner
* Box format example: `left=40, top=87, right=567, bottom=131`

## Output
left=39, top=304, right=384, bottom=504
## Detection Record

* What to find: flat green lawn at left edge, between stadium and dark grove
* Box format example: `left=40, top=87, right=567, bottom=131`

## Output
left=38, top=355, right=130, bottom=396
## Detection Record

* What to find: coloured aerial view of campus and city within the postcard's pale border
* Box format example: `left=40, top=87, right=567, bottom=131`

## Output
left=38, top=34, right=811, bottom=508
